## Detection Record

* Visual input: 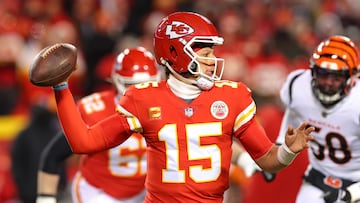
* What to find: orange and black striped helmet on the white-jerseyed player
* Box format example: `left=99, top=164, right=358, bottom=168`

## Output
left=310, top=35, right=359, bottom=105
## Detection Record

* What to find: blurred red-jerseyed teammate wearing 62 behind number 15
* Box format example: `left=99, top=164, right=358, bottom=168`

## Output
left=37, top=47, right=160, bottom=203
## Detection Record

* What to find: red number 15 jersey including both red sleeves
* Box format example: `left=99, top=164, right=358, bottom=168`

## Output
left=56, top=81, right=272, bottom=202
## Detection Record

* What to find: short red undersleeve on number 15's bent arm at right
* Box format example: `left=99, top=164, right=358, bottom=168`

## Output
left=239, top=118, right=273, bottom=159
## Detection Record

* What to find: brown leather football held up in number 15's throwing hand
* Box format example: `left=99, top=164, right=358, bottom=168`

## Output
left=29, top=43, right=77, bottom=86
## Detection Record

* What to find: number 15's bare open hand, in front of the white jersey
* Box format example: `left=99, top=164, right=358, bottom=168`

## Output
left=285, top=122, right=315, bottom=154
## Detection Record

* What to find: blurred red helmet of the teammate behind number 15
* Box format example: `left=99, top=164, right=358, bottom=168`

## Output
left=111, top=47, right=161, bottom=92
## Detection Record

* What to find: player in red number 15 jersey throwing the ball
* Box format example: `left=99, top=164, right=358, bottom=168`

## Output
left=47, top=12, right=314, bottom=203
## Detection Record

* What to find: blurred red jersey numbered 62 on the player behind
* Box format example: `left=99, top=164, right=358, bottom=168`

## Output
left=78, top=91, right=146, bottom=199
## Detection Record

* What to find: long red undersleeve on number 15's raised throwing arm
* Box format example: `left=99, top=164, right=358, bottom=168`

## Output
left=55, top=88, right=132, bottom=153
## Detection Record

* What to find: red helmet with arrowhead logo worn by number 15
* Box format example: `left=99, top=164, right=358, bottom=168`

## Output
left=154, top=12, right=224, bottom=89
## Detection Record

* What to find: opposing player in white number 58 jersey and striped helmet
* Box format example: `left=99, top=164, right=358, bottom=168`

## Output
left=277, top=36, right=360, bottom=203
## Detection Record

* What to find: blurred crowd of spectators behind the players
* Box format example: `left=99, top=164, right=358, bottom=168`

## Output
left=0, top=0, right=360, bottom=203
